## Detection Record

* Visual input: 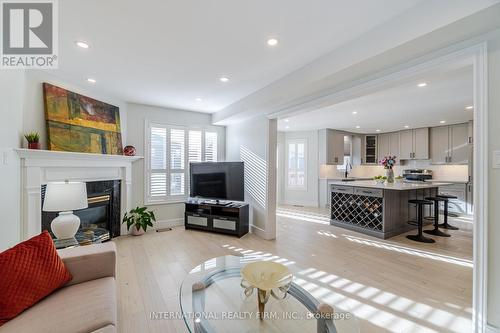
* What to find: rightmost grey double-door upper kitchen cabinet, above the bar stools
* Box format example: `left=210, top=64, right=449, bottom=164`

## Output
left=431, top=123, right=472, bottom=164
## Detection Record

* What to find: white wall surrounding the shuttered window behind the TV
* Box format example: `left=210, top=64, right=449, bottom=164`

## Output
left=127, top=103, right=226, bottom=226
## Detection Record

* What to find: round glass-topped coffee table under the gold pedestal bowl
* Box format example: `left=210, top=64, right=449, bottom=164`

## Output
left=180, top=256, right=359, bottom=333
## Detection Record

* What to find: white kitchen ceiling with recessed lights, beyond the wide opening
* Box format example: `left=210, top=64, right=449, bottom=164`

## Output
left=278, top=63, right=473, bottom=133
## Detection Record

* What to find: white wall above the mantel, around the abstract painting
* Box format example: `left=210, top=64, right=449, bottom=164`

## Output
left=23, top=70, right=127, bottom=149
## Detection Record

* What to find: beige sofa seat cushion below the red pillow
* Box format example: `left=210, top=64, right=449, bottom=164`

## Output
left=0, top=277, right=117, bottom=333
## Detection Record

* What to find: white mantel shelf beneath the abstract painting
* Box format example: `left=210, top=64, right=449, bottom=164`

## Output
left=15, top=148, right=144, bottom=162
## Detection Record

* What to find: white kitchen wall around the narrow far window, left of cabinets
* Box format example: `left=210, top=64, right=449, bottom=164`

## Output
left=278, top=131, right=319, bottom=207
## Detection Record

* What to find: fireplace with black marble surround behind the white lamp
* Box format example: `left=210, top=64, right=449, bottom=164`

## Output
left=41, top=180, right=121, bottom=238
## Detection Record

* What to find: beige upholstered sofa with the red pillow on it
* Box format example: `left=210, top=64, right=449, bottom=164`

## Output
left=0, top=242, right=117, bottom=333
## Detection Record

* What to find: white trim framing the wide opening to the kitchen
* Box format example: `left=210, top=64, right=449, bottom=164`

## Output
left=268, top=40, right=489, bottom=333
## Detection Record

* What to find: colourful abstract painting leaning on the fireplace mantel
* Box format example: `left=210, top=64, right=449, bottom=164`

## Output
left=43, top=83, right=123, bottom=155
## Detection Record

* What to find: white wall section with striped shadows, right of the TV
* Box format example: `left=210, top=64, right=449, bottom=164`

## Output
left=226, top=117, right=277, bottom=239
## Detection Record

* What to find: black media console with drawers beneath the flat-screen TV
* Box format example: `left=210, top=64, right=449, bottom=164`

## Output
left=184, top=199, right=248, bottom=237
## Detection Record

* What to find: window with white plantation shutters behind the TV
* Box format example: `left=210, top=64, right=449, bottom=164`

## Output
left=146, top=124, right=218, bottom=203
